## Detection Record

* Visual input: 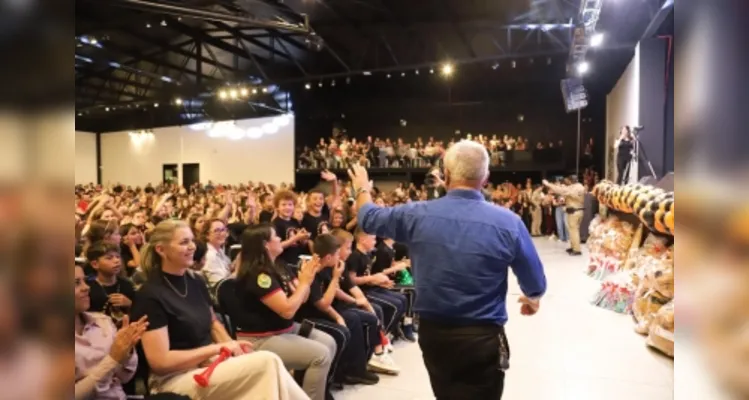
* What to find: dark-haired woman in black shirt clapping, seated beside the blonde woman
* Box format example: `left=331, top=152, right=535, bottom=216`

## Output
left=217, top=224, right=336, bottom=400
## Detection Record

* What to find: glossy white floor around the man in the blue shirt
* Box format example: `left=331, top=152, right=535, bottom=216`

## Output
left=334, top=239, right=674, bottom=400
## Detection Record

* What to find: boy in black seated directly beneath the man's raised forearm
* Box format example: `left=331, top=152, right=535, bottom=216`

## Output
left=346, top=228, right=407, bottom=340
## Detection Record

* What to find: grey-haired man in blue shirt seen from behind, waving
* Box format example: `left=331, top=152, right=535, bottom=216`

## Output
left=349, top=141, right=546, bottom=400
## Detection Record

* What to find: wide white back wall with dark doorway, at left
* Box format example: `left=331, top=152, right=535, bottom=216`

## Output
left=101, top=117, right=294, bottom=186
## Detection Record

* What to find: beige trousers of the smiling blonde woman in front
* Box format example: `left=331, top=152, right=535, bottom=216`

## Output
left=152, top=351, right=309, bottom=400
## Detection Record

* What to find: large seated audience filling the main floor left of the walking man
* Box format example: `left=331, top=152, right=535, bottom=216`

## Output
left=75, top=172, right=426, bottom=400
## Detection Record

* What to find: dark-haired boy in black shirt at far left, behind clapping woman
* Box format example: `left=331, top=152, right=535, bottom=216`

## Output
left=86, top=242, right=135, bottom=326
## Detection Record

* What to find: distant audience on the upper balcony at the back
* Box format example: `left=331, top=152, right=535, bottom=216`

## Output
left=297, top=134, right=564, bottom=169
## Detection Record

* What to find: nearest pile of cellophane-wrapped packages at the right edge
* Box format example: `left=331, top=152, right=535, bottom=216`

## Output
left=632, top=236, right=674, bottom=356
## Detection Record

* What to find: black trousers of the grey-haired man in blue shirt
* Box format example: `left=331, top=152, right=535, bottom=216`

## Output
left=419, top=317, right=509, bottom=400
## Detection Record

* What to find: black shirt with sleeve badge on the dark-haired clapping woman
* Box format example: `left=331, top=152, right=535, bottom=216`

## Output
left=218, top=265, right=296, bottom=336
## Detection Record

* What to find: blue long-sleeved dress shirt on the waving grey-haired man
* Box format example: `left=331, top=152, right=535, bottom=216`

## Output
left=358, top=189, right=546, bottom=325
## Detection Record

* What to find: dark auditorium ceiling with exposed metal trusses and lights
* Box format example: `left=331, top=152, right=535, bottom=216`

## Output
left=75, top=0, right=663, bottom=130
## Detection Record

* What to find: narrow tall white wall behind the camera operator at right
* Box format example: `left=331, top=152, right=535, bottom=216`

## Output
left=605, top=44, right=640, bottom=181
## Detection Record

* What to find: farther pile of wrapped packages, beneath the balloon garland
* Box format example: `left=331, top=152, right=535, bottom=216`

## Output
left=587, top=215, right=635, bottom=280
